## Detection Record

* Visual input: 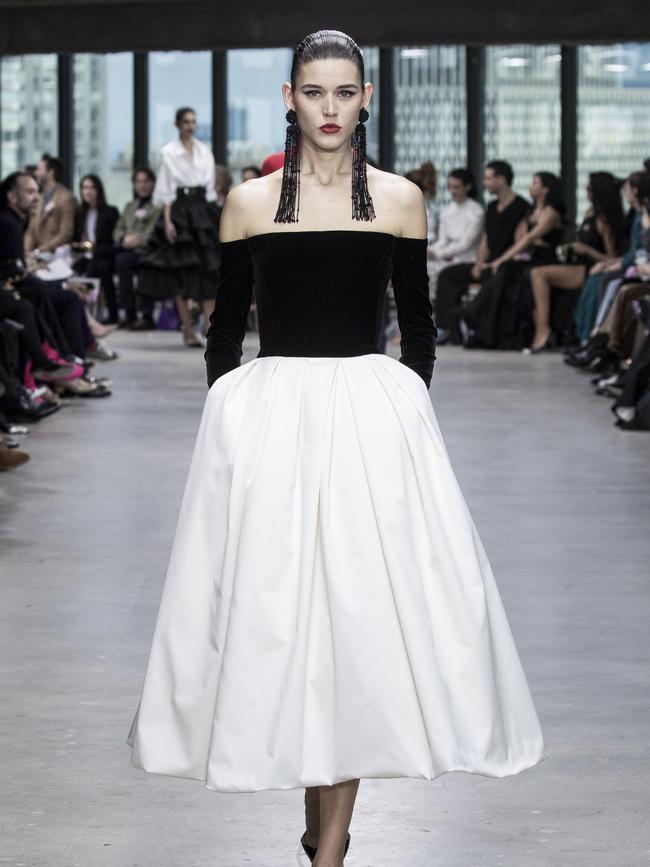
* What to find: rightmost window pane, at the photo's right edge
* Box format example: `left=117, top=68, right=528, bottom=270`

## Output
left=578, top=43, right=650, bottom=215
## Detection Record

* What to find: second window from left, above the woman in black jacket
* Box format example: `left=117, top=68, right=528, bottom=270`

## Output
left=73, top=54, right=133, bottom=209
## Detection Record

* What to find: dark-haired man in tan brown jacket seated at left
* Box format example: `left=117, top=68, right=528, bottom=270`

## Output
left=25, top=154, right=75, bottom=253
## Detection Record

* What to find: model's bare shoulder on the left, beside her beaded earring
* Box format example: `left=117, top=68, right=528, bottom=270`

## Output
left=219, top=169, right=282, bottom=241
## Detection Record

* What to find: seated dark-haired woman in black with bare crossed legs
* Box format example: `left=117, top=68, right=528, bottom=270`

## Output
left=531, top=172, right=625, bottom=350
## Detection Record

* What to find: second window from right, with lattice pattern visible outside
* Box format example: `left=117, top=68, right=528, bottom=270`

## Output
left=485, top=45, right=562, bottom=203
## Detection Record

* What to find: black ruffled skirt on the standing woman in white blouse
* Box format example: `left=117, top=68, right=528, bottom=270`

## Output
left=138, top=187, right=221, bottom=301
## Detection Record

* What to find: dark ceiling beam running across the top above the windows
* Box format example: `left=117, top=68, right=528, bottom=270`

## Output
left=0, top=0, right=650, bottom=54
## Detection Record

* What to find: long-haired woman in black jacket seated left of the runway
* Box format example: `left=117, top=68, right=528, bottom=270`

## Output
left=74, top=175, right=120, bottom=325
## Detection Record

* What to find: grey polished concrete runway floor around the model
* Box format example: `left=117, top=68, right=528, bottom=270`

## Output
left=0, top=333, right=650, bottom=867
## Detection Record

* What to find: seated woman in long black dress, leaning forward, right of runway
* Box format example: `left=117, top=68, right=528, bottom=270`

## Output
left=461, top=172, right=566, bottom=352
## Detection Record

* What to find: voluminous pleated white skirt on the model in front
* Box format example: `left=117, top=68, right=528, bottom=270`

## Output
left=128, top=354, right=543, bottom=792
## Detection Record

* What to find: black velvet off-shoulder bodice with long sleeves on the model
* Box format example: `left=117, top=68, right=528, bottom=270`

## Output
left=205, top=230, right=437, bottom=387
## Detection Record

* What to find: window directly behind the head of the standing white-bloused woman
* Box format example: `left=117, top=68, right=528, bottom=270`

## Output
left=149, top=51, right=212, bottom=169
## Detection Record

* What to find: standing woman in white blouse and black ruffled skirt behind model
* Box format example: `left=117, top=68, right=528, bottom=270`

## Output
left=138, top=108, right=221, bottom=347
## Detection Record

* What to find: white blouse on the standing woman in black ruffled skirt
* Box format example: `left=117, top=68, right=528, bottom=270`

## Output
left=153, top=138, right=217, bottom=205
